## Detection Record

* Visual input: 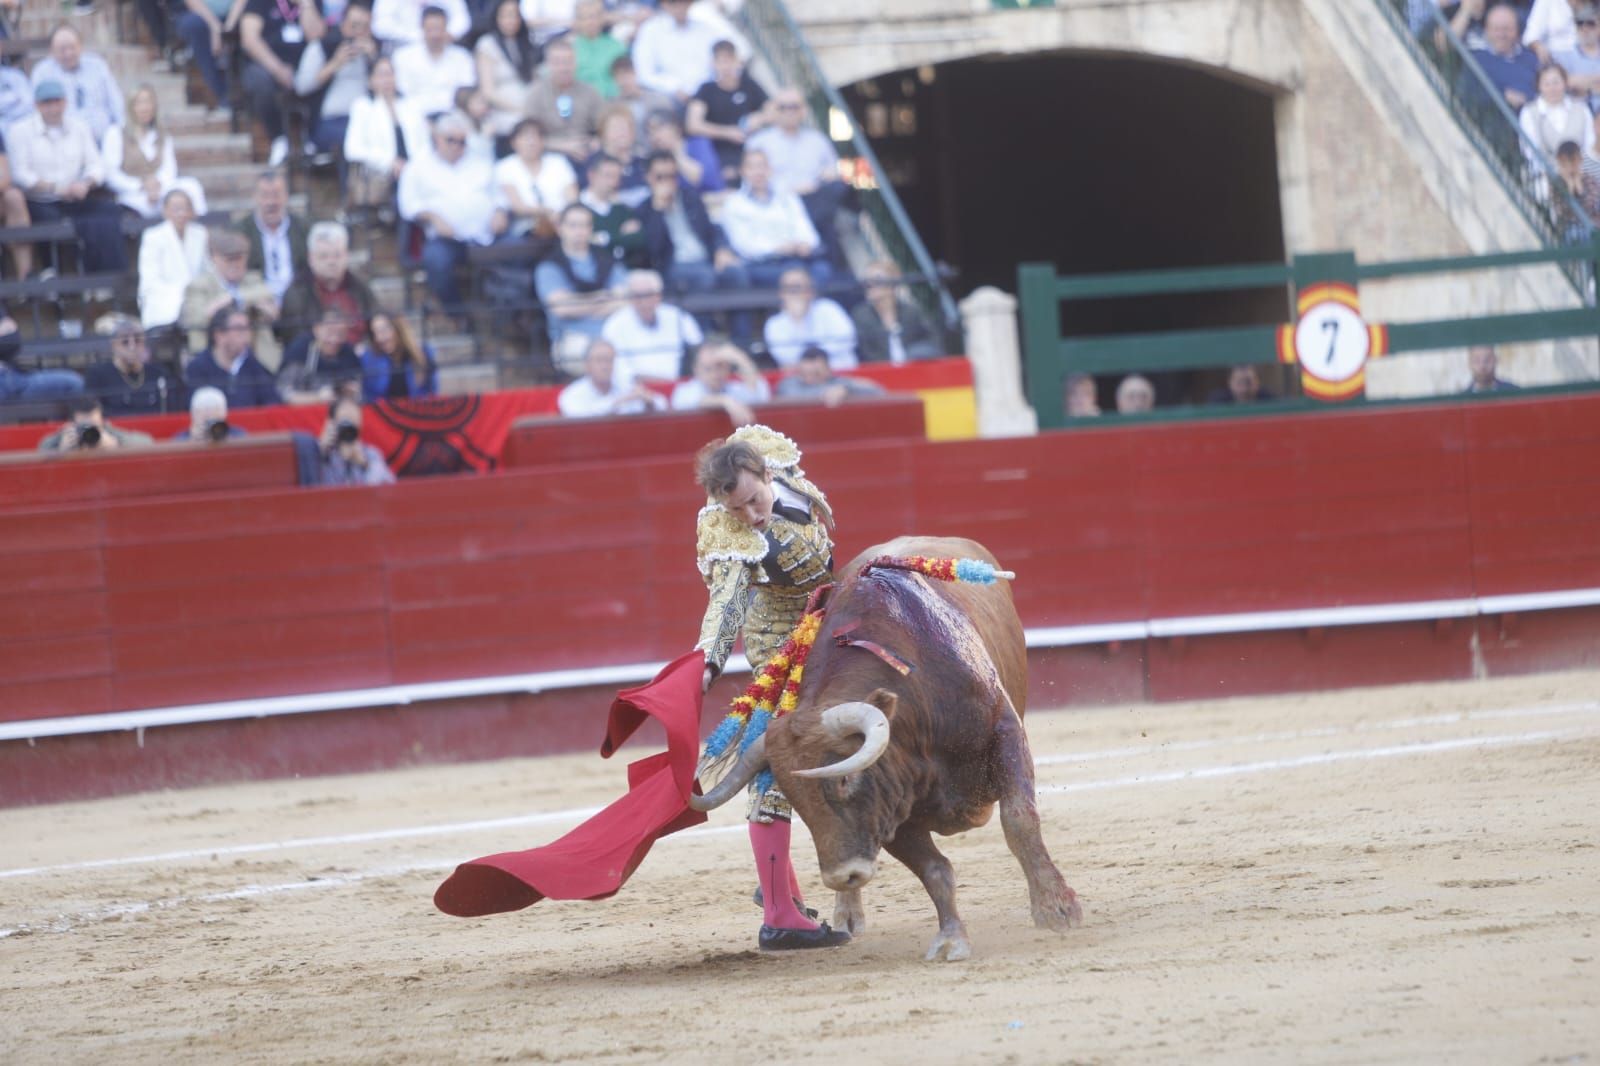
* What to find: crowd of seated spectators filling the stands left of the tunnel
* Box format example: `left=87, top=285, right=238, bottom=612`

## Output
left=0, top=0, right=946, bottom=454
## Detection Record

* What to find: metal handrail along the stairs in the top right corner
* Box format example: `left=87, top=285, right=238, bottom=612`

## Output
left=1376, top=0, right=1595, bottom=292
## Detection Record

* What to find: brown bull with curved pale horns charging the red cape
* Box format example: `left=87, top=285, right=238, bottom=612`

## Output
left=693, top=536, right=1083, bottom=962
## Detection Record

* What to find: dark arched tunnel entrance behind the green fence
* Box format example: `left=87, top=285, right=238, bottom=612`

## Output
left=843, top=53, right=1288, bottom=402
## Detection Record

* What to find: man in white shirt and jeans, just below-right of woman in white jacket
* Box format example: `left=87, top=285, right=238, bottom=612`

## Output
left=400, top=112, right=507, bottom=319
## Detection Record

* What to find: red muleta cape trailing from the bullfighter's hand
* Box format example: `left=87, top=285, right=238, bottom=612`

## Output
left=434, top=651, right=706, bottom=917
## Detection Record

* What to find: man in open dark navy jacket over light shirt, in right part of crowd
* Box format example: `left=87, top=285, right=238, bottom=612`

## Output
left=638, top=152, right=752, bottom=337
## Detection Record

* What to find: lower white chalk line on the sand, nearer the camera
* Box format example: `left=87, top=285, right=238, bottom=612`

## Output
left=0, top=704, right=1600, bottom=940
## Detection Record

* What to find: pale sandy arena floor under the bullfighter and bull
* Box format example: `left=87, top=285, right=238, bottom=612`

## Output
left=0, top=674, right=1600, bottom=1066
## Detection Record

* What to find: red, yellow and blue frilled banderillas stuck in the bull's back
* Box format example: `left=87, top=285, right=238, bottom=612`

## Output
left=701, top=555, right=1016, bottom=792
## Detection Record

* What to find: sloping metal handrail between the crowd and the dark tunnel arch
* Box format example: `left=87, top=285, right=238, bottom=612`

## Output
left=738, top=0, right=960, bottom=331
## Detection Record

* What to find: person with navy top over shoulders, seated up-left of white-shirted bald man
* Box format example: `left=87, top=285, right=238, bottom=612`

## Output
left=533, top=203, right=627, bottom=373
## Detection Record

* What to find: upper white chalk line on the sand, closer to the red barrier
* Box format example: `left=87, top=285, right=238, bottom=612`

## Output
left=0, top=699, right=1600, bottom=880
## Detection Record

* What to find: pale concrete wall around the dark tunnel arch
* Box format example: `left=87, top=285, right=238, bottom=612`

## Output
left=790, top=0, right=1600, bottom=397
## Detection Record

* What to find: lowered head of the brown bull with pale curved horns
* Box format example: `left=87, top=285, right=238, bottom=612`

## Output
left=690, top=688, right=899, bottom=892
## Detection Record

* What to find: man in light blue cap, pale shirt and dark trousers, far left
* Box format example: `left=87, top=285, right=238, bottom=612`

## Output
left=5, top=78, right=128, bottom=272
